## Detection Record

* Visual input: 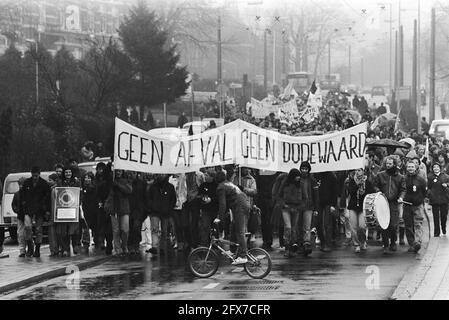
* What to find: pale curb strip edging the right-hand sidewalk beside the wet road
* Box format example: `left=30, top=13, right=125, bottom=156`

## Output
left=389, top=208, right=439, bottom=300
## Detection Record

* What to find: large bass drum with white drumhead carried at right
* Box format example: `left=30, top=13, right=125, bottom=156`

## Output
left=363, top=192, right=390, bottom=230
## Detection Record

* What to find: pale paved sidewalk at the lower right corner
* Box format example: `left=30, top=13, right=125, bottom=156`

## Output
left=391, top=206, right=449, bottom=300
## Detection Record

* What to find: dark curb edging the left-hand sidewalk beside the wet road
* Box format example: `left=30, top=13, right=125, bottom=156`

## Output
left=0, top=256, right=113, bottom=294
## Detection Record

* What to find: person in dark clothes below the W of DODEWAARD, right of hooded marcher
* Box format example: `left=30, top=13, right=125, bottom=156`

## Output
left=315, top=172, right=338, bottom=252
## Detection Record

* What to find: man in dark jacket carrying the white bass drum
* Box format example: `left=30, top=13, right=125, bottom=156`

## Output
left=374, top=156, right=406, bottom=254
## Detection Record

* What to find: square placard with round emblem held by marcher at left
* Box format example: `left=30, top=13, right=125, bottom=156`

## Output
left=51, top=187, right=80, bottom=222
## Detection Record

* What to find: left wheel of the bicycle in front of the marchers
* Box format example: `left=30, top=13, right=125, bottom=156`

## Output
left=188, top=247, right=219, bottom=278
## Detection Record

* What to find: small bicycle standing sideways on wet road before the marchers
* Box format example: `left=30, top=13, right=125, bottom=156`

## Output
left=187, top=227, right=272, bottom=279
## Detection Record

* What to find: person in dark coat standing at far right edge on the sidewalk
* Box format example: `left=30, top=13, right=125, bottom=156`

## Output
left=427, top=162, right=449, bottom=237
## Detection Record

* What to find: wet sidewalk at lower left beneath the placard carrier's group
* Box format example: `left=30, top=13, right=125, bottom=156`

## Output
left=0, top=245, right=111, bottom=294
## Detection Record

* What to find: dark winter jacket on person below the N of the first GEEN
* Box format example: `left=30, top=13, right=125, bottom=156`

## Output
left=146, top=181, right=176, bottom=218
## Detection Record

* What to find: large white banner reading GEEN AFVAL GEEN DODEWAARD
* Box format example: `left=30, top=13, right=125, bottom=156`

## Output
left=114, top=118, right=367, bottom=174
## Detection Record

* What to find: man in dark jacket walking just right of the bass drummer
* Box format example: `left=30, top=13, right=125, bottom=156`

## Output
left=399, top=160, right=427, bottom=253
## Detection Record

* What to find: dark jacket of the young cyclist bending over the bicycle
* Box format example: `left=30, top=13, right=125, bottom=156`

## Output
left=217, top=181, right=250, bottom=220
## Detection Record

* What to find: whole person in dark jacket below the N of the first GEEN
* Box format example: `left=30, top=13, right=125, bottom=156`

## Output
left=146, top=174, right=176, bottom=255
